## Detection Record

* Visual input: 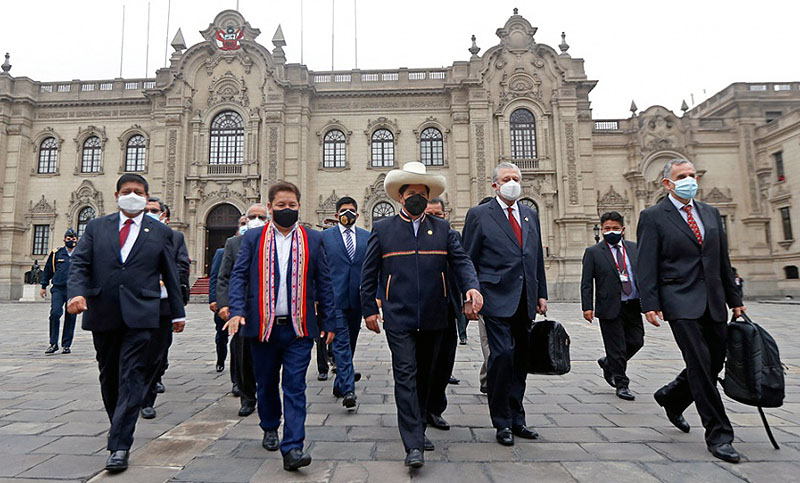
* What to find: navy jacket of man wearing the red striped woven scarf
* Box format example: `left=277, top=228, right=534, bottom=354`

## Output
left=228, top=226, right=338, bottom=337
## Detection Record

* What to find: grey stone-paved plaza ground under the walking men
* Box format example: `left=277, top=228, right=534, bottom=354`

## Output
left=0, top=303, right=800, bottom=483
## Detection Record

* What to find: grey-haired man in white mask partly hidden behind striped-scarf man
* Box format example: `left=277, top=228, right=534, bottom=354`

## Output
left=217, top=208, right=268, bottom=418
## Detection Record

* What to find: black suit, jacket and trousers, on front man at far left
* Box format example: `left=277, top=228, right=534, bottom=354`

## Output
left=67, top=213, right=185, bottom=451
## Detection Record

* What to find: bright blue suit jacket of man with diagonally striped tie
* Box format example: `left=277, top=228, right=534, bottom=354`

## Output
left=322, top=226, right=369, bottom=317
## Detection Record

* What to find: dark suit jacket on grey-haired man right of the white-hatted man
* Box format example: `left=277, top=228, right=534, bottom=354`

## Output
left=462, top=199, right=547, bottom=320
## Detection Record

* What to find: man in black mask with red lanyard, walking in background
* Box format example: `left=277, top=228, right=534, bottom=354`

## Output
left=581, top=211, right=644, bottom=401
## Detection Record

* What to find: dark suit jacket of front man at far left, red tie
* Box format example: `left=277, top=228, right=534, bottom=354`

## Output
left=67, top=212, right=185, bottom=332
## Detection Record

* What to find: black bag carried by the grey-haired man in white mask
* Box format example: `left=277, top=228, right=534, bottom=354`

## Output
left=528, top=319, right=570, bottom=375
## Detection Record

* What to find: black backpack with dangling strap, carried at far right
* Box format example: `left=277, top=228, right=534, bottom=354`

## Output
left=721, top=313, right=785, bottom=449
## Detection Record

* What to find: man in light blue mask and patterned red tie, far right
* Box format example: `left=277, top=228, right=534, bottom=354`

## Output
left=636, top=159, right=745, bottom=463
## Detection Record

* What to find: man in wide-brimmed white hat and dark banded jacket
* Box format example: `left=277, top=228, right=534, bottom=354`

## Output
left=361, top=162, right=483, bottom=468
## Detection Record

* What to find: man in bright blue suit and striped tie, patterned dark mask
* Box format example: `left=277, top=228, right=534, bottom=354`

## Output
left=322, top=196, right=369, bottom=409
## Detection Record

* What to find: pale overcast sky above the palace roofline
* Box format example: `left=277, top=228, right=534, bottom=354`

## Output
left=0, top=0, right=800, bottom=119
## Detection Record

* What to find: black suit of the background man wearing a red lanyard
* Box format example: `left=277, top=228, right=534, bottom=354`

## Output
left=581, top=240, right=644, bottom=388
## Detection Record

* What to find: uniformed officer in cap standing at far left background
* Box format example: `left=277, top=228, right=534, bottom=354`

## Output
left=39, top=228, right=78, bottom=354
